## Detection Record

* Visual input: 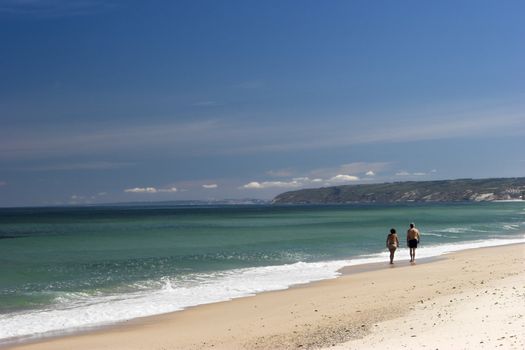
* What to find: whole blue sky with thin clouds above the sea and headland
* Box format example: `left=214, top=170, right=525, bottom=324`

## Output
left=0, top=0, right=525, bottom=206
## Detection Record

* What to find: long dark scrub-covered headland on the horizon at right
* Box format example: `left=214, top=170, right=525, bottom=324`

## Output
left=273, top=177, right=525, bottom=204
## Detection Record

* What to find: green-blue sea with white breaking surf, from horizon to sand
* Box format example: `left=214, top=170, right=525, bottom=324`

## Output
left=0, top=202, right=525, bottom=344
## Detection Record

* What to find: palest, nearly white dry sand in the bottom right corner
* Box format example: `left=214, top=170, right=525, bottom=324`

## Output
left=327, top=275, right=525, bottom=350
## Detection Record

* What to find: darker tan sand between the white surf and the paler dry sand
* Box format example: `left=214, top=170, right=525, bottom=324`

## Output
left=3, top=244, right=525, bottom=350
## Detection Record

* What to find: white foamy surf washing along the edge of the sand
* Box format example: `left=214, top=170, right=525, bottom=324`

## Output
left=0, top=235, right=525, bottom=344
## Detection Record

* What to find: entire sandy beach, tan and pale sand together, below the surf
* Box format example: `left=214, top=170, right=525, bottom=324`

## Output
left=8, top=244, right=525, bottom=350
